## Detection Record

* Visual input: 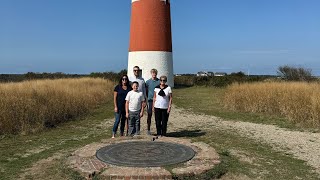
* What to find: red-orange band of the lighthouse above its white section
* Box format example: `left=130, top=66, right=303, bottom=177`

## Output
left=129, top=0, right=172, bottom=52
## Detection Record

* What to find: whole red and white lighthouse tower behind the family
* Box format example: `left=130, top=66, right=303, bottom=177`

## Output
left=128, top=0, right=174, bottom=87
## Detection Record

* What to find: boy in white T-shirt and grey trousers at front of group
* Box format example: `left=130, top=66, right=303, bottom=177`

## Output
left=126, top=81, right=145, bottom=136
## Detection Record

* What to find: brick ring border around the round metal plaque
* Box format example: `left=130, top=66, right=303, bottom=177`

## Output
left=66, top=136, right=220, bottom=179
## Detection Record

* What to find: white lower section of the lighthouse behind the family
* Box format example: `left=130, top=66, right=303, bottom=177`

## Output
left=128, top=51, right=174, bottom=87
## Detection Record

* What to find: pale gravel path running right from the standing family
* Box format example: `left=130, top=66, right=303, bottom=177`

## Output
left=144, top=107, right=320, bottom=174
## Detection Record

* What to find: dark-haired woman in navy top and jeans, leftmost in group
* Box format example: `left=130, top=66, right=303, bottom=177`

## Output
left=112, top=75, right=132, bottom=138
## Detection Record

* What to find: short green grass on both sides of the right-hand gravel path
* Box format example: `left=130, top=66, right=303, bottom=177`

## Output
left=173, top=87, right=319, bottom=180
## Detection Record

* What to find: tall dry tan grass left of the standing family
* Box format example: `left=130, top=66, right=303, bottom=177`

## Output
left=0, top=78, right=113, bottom=134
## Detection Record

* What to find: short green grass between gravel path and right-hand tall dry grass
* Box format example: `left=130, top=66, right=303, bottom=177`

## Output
left=174, top=86, right=296, bottom=128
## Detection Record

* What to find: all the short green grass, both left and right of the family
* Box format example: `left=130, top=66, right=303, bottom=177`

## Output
left=0, top=84, right=318, bottom=179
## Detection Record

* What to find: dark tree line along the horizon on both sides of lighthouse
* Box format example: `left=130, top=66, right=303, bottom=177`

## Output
left=0, top=65, right=317, bottom=84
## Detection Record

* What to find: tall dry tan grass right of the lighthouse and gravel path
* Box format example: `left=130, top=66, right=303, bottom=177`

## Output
left=224, top=82, right=320, bottom=127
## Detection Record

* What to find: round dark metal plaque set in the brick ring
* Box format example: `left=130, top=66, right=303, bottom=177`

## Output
left=96, top=141, right=195, bottom=167
